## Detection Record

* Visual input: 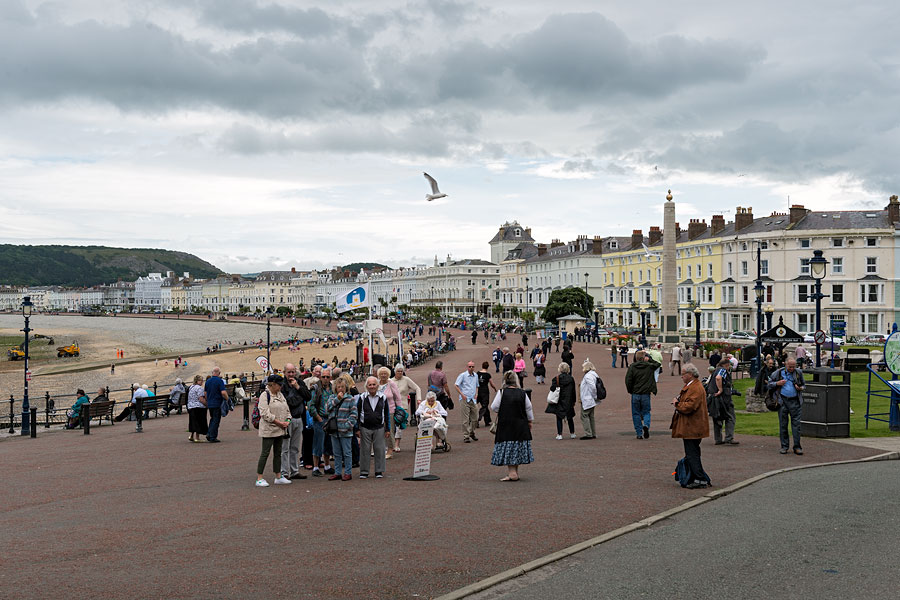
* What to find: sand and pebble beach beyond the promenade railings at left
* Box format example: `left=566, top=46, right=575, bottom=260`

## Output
left=0, top=315, right=394, bottom=409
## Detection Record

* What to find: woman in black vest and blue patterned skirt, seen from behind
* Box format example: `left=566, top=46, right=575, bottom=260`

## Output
left=491, top=371, right=534, bottom=481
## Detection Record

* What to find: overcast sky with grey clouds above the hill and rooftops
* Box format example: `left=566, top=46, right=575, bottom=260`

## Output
left=0, top=0, right=900, bottom=272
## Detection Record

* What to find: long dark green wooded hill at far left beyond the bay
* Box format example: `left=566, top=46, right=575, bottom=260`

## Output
left=0, top=244, right=222, bottom=287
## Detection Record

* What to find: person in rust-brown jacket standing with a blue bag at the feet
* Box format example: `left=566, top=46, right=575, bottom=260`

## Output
left=671, top=363, right=709, bottom=489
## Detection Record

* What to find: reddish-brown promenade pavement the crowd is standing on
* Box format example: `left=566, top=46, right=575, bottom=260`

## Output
left=0, top=332, right=880, bottom=598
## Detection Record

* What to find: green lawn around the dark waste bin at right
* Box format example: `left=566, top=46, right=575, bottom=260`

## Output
left=734, top=371, right=900, bottom=438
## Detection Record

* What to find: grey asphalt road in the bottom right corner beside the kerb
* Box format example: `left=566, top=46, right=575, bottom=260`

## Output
left=470, top=461, right=900, bottom=600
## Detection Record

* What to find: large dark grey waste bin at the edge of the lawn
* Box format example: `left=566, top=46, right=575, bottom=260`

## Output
left=800, top=367, right=850, bottom=438
